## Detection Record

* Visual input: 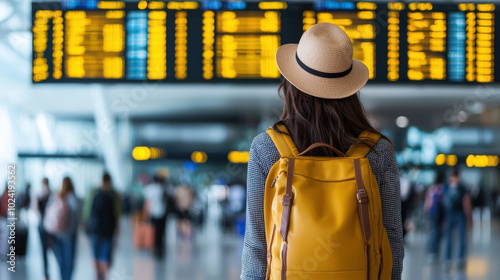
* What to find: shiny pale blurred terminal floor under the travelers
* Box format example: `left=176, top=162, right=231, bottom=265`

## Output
left=0, top=221, right=500, bottom=280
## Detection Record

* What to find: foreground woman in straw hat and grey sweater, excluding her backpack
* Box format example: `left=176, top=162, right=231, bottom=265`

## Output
left=241, top=23, right=404, bottom=280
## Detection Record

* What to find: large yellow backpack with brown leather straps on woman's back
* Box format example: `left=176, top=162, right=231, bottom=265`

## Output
left=264, top=125, right=392, bottom=280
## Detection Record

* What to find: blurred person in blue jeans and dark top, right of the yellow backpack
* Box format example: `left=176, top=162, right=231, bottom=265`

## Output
left=443, top=169, right=472, bottom=270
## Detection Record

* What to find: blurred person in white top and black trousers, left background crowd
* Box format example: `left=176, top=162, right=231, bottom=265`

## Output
left=144, top=175, right=167, bottom=258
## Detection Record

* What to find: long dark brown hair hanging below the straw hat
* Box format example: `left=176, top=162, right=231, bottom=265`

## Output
left=273, top=79, right=387, bottom=156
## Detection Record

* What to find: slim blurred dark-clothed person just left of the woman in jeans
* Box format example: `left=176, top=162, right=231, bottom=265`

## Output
left=35, top=178, right=51, bottom=280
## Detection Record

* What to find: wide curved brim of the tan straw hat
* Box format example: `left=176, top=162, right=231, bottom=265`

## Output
left=276, top=44, right=368, bottom=99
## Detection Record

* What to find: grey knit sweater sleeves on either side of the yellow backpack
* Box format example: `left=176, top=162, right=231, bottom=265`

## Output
left=241, top=133, right=404, bottom=280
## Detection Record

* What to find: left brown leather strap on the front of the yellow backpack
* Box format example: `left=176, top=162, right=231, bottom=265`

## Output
left=280, top=158, right=295, bottom=280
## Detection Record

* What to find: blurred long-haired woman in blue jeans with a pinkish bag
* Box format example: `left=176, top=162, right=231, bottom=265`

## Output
left=50, top=177, right=79, bottom=280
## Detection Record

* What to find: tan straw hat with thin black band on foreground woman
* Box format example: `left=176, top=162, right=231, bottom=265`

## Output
left=276, top=22, right=368, bottom=99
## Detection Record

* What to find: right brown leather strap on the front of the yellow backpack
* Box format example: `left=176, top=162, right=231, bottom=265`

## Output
left=354, top=158, right=372, bottom=280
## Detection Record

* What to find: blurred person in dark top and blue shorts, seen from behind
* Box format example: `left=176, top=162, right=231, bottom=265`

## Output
left=85, top=173, right=121, bottom=280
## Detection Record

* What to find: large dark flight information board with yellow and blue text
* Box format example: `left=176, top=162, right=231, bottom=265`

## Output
left=32, top=0, right=500, bottom=84
